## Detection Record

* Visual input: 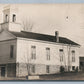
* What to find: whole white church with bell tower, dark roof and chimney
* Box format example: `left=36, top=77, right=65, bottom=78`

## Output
left=0, top=7, right=80, bottom=77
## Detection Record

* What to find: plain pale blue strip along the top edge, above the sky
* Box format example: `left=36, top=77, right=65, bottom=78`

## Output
left=0, top=0, right=84, bottom=3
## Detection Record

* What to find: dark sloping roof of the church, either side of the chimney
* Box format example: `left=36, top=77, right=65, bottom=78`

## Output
left=11, top=31, right=79, bottom=45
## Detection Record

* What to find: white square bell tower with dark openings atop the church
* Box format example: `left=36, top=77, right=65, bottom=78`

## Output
left=1, top=5, right=21, bottom=32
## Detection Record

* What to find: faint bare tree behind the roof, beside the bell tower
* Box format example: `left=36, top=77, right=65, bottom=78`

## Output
left=21, top=18, right=34, bottom=31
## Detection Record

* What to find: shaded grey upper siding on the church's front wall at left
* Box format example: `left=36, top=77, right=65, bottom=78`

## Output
left=0, top=40, right=16, bottom=64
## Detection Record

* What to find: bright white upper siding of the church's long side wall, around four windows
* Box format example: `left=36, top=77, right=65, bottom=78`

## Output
left=16, top=39, right=79, bottom=66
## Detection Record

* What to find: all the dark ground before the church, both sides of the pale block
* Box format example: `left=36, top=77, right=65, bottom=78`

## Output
left=0, top=72, right=84, bottom=81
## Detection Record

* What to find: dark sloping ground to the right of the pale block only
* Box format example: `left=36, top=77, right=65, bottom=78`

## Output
left=40, top=72, right=84, bottom=81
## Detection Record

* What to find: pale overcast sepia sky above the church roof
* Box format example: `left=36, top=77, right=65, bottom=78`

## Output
left=0, top=4, right=84, bottom=55
